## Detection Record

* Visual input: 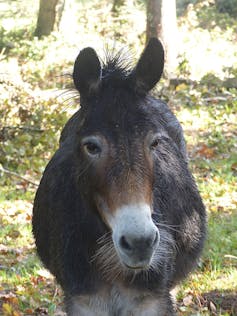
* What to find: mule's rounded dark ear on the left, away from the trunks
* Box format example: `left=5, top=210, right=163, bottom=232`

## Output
left=72, top=47, right=101, bottom=96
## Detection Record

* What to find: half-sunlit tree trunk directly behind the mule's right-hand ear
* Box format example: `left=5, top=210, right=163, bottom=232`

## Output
left=146, top=0, right=177, bottom=78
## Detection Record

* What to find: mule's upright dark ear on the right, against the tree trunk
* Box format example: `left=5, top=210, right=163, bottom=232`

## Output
left=132, top=38, right=164, bottom=93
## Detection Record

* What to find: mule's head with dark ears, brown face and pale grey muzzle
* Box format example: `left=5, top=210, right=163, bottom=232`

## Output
left=73, top=39, right=174, bottom=269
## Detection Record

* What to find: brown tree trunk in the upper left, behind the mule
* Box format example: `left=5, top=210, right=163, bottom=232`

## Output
left=35, top=0, right=62, bottom=37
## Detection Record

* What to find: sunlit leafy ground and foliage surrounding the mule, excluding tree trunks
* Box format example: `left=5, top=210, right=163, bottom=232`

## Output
left=0, top=0, right=237, bottom=316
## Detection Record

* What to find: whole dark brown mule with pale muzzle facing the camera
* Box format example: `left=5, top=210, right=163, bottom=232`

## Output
left=33, top=39, right=206, bottom=316
